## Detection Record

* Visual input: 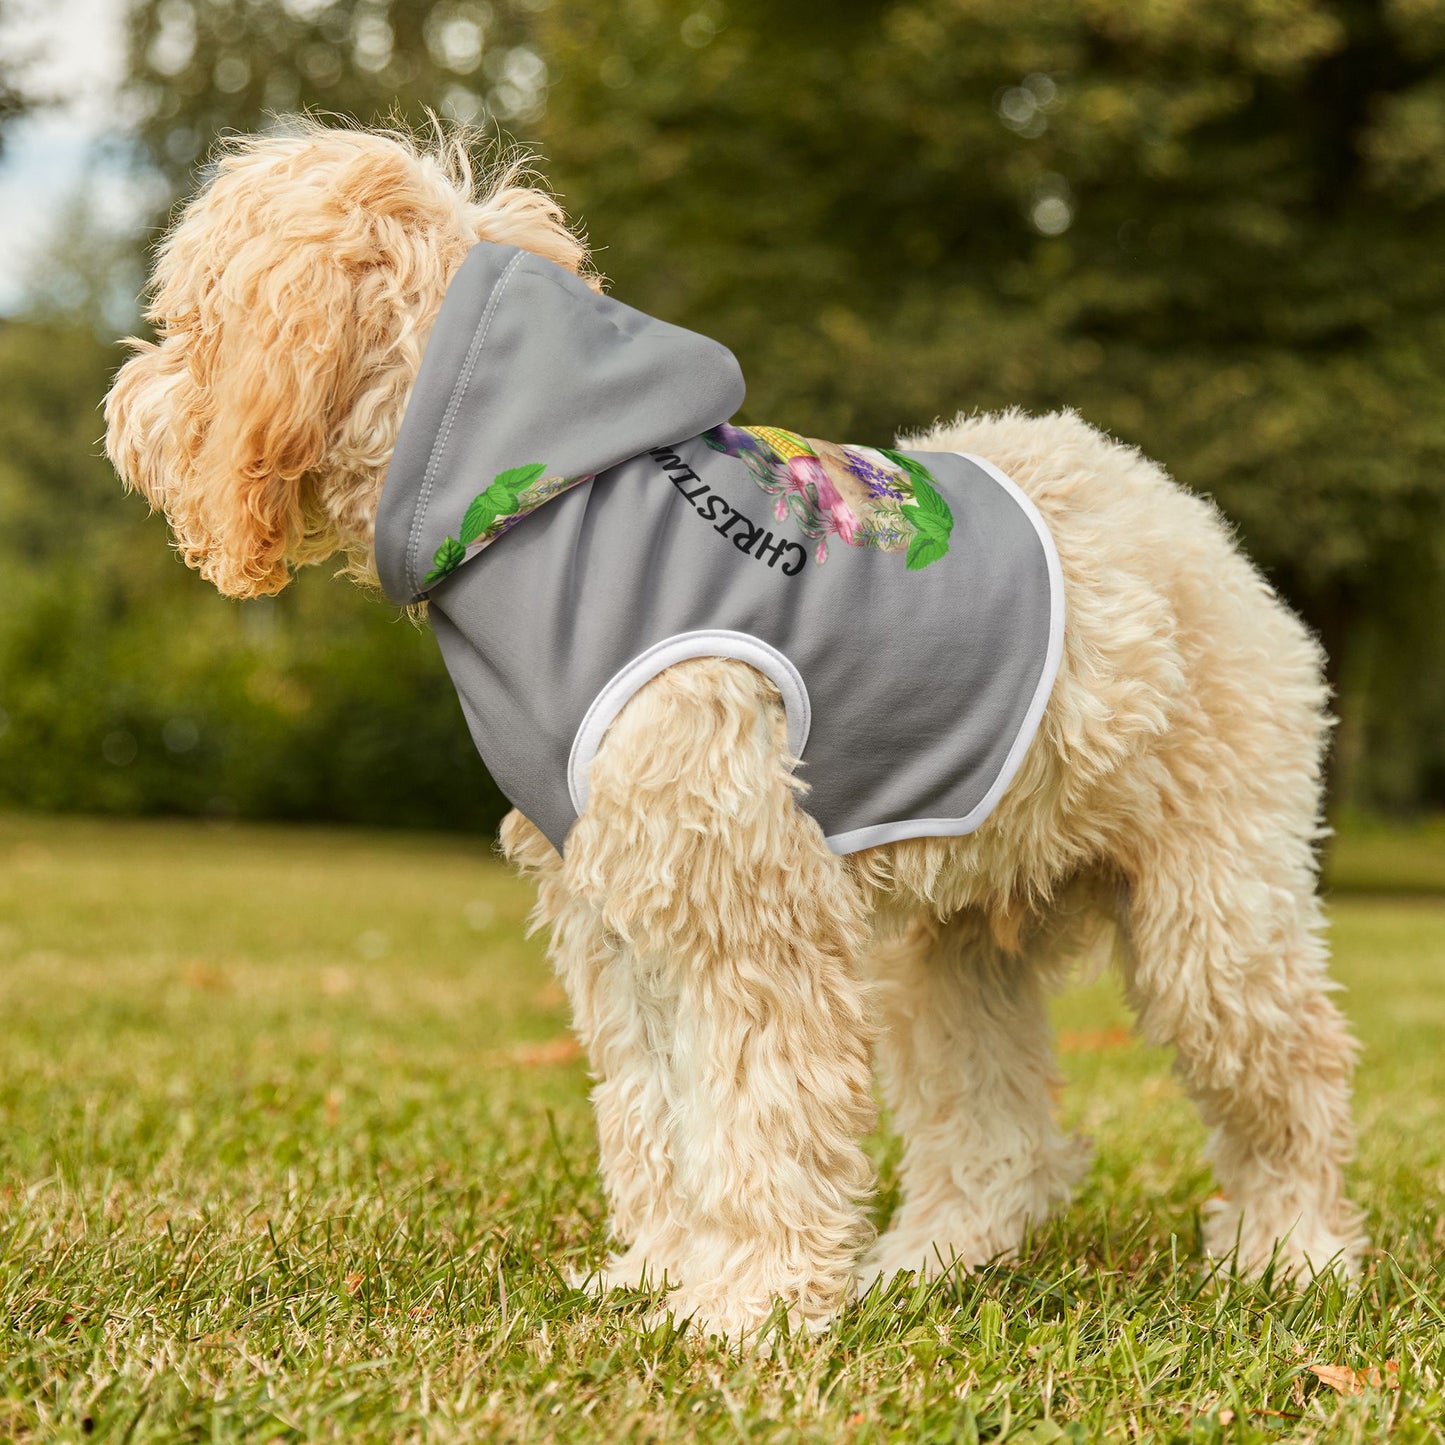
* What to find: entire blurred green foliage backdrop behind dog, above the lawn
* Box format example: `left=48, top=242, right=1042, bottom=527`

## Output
left=0, top=0, right=1445, bottom=827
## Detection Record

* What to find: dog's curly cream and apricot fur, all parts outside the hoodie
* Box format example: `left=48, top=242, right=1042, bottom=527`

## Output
left=107, top=124, right=1364, bottom=1338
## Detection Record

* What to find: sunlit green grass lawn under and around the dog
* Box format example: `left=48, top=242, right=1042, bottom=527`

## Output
left=0, top=818, right=1445, bottom=1445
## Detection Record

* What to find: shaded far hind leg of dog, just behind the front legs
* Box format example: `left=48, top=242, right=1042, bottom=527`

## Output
left=860, top=912, right=1088, bottom=1285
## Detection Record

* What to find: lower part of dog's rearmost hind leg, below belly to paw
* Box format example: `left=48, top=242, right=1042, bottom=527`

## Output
left=1126, top=827, right=1364, bottom=1274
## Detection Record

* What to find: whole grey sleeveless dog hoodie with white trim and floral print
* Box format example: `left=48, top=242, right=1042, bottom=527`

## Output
left=376, top=241, right=1064, bottom=853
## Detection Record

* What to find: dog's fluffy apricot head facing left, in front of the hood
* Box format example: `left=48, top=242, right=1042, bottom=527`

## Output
left=105, top=124, right=587, bottom=597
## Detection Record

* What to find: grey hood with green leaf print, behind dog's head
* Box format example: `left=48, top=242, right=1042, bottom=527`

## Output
left=376, top=241, right=744, bottom=605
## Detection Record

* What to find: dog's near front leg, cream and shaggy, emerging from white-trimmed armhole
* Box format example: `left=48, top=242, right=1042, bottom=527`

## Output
left=564, top=660, right=874, bottom=1340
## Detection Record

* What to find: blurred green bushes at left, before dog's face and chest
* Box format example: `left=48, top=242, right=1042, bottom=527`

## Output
left=0, top=316, right=506, bottom=829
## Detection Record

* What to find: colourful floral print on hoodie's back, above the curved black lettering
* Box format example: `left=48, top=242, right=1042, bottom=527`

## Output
left=702, top=422, right=954, bottom=571
